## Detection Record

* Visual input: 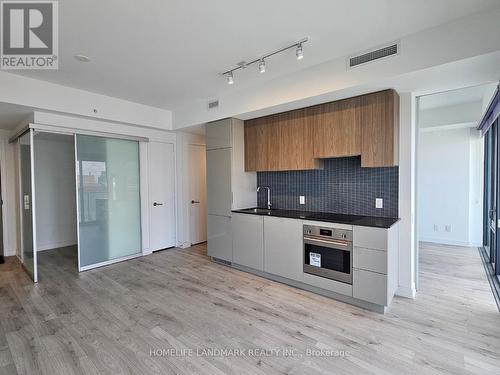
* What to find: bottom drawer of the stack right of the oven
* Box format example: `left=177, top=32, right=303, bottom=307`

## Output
left=352, top=268, right=389, bottom=306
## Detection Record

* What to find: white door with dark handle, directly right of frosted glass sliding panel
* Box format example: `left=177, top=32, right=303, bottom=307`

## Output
left=149, top=142, right=176, bottom=251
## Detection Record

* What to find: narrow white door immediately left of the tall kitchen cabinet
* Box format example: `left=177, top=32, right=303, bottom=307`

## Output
left=189, top=145, right=207, bottom=245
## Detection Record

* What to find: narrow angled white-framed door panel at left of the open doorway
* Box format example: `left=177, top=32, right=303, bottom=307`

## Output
left=18, top=129, right=38, bottom=283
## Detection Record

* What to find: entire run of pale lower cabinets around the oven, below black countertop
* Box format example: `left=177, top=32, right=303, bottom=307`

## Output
left=225, top=213, right=399, bottom=312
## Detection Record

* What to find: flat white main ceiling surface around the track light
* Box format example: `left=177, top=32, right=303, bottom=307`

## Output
left=10, top=0, right=499, bottom=109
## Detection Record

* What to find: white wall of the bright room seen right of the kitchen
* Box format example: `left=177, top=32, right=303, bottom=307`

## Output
left=418, top=128, right=483, bottom=246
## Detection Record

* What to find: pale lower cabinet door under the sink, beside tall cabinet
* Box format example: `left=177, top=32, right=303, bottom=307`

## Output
left=232, top=213, right=264, bottom=271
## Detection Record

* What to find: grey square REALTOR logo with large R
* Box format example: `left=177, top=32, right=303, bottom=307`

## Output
left=0, top=0, right=59, bottom=70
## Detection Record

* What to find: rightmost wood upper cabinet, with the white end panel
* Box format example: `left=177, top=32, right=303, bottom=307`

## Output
left=360, top=90, right=399, bottom=167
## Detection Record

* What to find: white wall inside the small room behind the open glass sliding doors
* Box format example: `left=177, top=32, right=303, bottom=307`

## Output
left=35, top=134, right=77, bottom=251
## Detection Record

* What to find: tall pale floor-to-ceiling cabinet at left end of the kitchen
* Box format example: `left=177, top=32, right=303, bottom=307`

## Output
left=206, top=118, right=257, bottom=262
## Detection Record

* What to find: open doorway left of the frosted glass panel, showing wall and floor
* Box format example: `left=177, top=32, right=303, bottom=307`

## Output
left=33, top=133, right=78, bottom=279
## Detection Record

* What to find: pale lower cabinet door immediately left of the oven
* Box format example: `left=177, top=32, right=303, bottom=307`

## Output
left=264, top=217, right=303, bottom=282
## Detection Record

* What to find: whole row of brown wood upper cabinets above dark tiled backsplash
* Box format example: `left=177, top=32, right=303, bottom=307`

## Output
left=245, top=90, right=399, bottom=171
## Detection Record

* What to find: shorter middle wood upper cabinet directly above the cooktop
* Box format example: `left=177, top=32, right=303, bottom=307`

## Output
left=309, top=97, right=361, bottom=158
